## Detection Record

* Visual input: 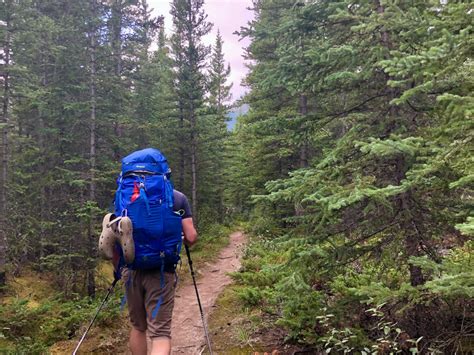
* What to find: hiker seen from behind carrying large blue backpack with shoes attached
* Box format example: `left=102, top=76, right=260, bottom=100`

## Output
left=99, top=148, right=197, bottom=355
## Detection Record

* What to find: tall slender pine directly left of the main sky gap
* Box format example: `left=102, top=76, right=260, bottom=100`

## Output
left=171, top=0, right=212, bottom=221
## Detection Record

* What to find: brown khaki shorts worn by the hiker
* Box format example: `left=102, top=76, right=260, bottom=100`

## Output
left=123, top=269, right=176, bottom=339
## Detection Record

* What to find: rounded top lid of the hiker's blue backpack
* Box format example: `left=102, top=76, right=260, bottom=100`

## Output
left=122, top=148, right=171, bottom=176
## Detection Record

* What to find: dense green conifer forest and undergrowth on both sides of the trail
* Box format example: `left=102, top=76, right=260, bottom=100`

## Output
left=0, top=0, right=474, bottom=354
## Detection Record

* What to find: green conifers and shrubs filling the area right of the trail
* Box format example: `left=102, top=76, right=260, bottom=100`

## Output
left=230, top=0, right=473, bottom=352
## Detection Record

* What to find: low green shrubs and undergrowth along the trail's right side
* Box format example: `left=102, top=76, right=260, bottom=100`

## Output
left=233, top=221, right=474, bottom=354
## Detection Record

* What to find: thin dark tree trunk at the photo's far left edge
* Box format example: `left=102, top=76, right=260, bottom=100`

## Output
left=0, top=1, right=11, bottom=287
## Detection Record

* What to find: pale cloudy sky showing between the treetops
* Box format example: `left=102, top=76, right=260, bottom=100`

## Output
left=148, top=0, right=253, bottom=101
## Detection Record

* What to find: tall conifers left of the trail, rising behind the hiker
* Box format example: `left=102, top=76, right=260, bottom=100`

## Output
left=0, top=0, right=233, bottom=297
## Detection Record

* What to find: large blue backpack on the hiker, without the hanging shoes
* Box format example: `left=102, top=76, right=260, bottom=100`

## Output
left=115, top=148, right=182, bottom=272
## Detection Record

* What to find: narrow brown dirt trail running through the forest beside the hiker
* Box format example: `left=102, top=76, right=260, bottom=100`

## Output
left=171, top=232, right=245, bottom=355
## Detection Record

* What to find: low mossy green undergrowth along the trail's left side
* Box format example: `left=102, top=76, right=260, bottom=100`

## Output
left=0, top=225, right=231, bottom=354
